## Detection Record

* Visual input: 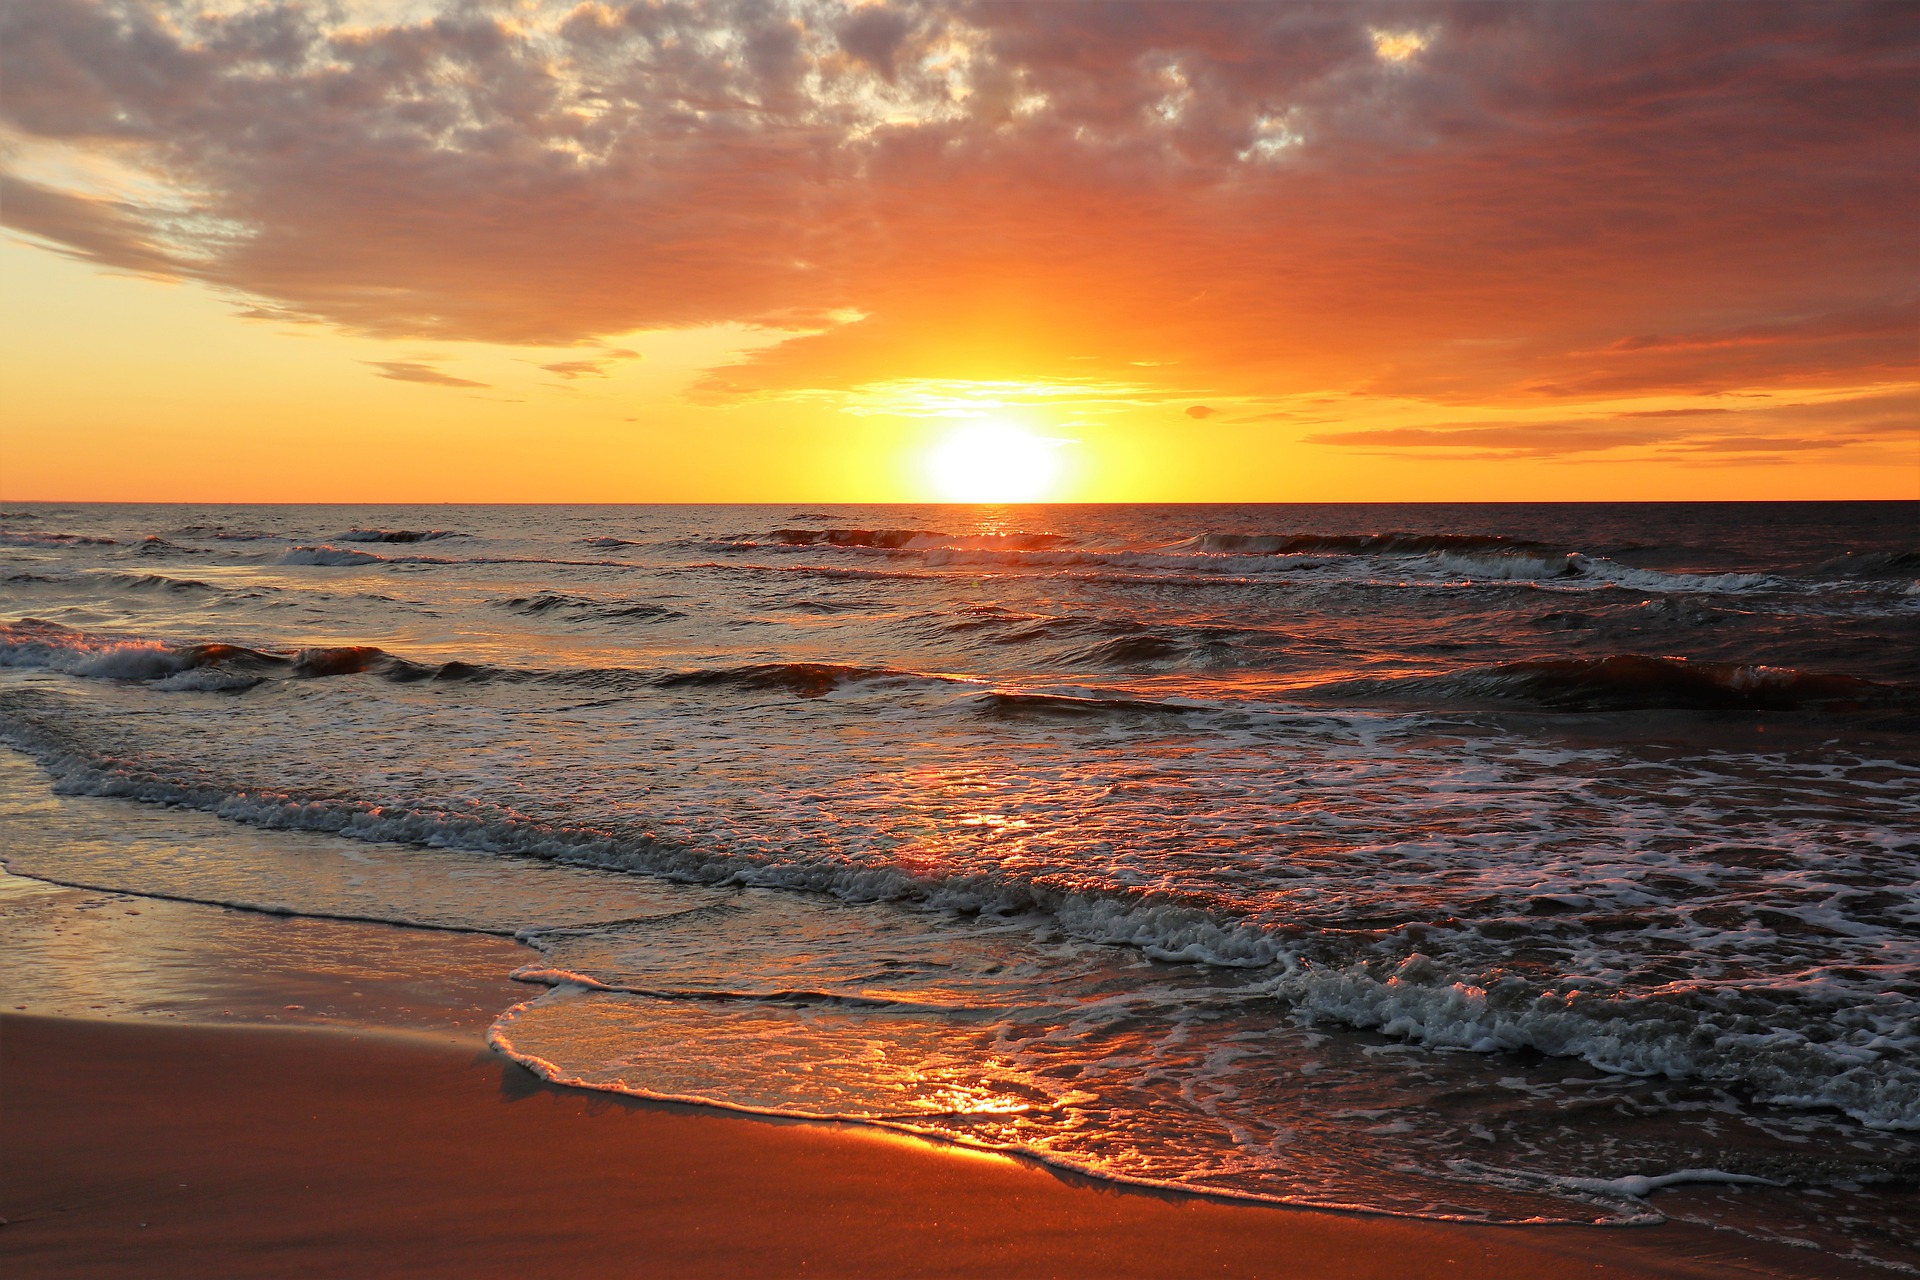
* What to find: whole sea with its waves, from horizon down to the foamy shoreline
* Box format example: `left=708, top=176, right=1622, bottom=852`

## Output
left=0, top=503, right=1920, bottom=1267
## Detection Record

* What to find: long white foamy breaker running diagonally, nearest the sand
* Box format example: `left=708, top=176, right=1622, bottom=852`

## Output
left=0, top=710, right=1920, bottom=1130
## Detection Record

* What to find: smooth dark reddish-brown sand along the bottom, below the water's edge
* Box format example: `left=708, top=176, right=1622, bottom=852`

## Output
left=0, top=1015, right=1885, bottom=1280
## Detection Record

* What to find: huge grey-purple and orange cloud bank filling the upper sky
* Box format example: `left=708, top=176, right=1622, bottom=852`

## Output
left=0, top=0, right=1920, bottom=416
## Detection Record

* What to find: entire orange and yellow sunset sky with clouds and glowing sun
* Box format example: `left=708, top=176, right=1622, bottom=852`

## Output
left=0, top=0, right=1920, bottom=503
